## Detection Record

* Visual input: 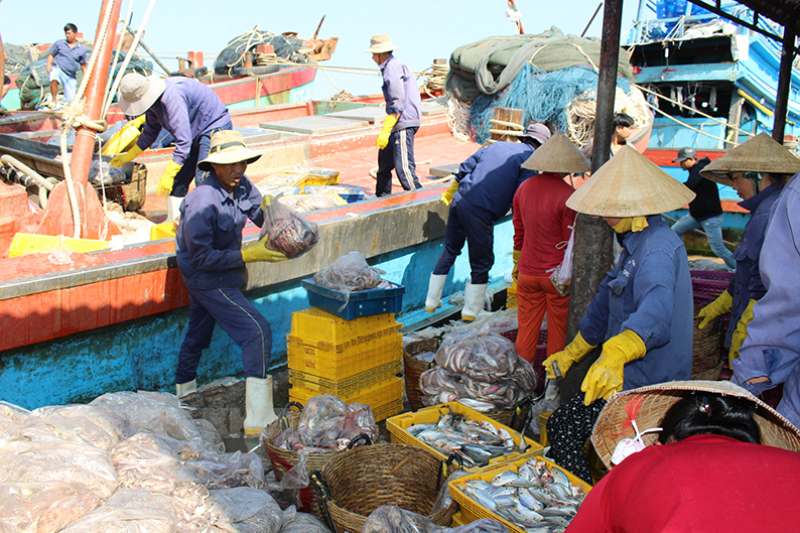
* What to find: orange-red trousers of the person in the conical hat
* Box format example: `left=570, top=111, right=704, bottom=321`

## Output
left=517, top=273, right=569, bottom=363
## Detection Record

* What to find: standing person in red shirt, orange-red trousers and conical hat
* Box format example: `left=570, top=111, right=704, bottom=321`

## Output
left=514, top=132, right=590, bottom=363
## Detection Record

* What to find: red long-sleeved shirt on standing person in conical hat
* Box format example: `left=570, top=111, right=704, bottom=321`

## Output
left=514, top=172, right=575, bottom=276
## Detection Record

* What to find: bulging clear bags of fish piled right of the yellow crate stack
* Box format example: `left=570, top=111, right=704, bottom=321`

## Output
left=419, top=329, right=537, bottom=413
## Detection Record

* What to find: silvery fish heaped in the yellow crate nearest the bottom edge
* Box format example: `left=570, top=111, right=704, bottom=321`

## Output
left=461, top=457, right=585, bottom=533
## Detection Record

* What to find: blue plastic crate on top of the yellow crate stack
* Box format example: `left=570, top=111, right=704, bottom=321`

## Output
left=301, top=279, right=406, bottom=320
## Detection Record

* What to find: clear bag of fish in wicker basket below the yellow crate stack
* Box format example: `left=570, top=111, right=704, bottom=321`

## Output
left=272, top=394, right=378, bottom=452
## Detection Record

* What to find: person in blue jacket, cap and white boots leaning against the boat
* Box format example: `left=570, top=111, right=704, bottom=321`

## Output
left=425, top=123, right=550, bottom=321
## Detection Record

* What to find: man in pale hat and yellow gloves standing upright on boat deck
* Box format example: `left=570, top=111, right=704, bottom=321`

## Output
left=364, top=35, right=422, bottom=196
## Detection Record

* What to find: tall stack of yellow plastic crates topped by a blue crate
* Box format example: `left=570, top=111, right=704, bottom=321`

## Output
left=287, top=281, right=403, bottom=421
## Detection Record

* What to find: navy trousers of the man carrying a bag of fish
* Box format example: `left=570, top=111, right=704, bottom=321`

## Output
left=175, top=288, right=272, bottom=383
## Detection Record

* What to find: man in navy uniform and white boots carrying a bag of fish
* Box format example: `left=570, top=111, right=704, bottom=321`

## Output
left=175, top=130, right=286, bottom=434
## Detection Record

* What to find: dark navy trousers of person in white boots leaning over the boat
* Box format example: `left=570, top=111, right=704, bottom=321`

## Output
left=433, top=201, right=494, bottom=285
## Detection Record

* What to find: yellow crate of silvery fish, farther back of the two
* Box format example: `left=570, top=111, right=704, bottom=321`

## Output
left=386, top=402, right=543, bottom=472
